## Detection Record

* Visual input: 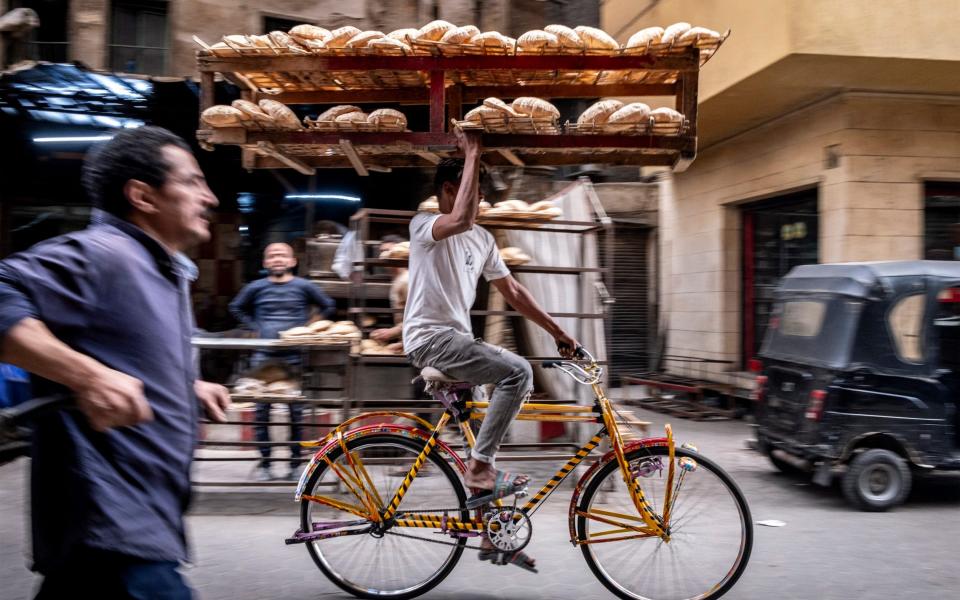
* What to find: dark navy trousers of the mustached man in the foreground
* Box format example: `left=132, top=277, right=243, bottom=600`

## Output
left=35, top=548, right=193, bottom=600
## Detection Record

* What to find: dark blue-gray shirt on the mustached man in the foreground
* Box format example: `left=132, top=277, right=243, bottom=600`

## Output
left=0, top=216, right=199, bottom=573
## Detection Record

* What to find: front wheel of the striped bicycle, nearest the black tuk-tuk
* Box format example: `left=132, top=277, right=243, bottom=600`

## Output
left=575, top=446, right=753, bottom=600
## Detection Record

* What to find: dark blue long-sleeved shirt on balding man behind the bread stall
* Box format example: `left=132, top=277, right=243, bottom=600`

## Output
left=230, top=277, right=337, bottom=338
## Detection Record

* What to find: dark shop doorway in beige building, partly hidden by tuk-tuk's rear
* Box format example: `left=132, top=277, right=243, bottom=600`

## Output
left=742, top=188, right=819, bottom=364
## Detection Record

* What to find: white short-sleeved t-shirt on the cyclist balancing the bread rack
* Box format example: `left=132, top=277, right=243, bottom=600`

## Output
left=403, top=213, right=510, bottom=353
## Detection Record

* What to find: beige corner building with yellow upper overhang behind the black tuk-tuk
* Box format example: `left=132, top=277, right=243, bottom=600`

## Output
left=602, top=0, right=960, bottom=381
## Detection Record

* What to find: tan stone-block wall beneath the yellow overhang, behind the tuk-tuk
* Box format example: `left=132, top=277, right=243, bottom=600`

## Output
left=660, top=93, right=960, bottom=374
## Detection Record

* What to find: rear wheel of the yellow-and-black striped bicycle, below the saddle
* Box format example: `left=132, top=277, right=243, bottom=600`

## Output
left=300, top=434, right=469, bottom=600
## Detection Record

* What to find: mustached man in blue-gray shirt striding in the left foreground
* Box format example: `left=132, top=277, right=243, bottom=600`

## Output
left=0, top=127, right=230, bottom=599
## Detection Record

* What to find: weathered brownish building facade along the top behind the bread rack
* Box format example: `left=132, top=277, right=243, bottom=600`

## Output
left=0, top=0, right=598, bottom=77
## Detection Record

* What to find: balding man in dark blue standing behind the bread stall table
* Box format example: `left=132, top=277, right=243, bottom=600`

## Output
left=230, top=243, right=337, bottom=481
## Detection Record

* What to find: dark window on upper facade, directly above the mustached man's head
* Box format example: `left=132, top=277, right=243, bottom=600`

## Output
left=110, top=0, right=167, bottom=75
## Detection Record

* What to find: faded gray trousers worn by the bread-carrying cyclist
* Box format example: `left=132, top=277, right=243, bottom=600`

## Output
left=409, top=330, right=533, bottom=463
